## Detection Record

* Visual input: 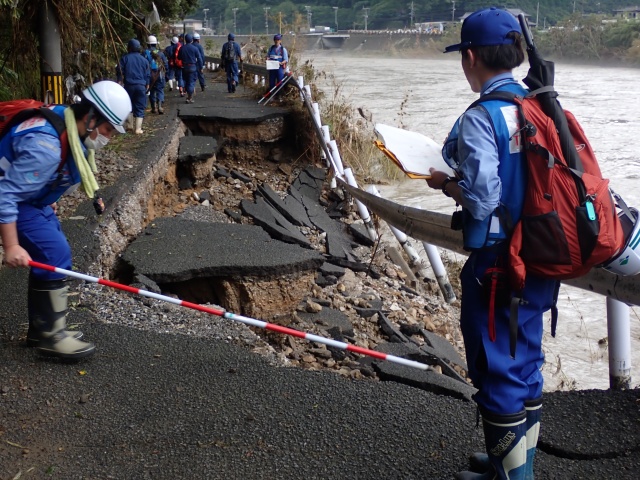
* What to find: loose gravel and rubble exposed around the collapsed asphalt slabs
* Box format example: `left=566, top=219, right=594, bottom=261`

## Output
left=48, top=117, right=465, bottom=390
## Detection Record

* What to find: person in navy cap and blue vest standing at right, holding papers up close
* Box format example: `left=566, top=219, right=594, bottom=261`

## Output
left=427, top=8, right=557, bottom=480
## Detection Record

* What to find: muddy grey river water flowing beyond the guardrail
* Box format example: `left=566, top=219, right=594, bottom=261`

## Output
left=305, top=50, right=640, bottom=390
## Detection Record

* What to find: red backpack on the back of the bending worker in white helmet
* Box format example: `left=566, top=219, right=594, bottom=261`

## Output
left=0, top=99, right=69, bottom=164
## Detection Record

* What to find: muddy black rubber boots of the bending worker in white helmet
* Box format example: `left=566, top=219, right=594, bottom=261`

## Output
left=27, top=279, right=96, bottom=360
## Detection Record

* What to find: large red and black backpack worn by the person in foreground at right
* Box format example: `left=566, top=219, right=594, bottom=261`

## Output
left=469, top=91, right=625, bottom=292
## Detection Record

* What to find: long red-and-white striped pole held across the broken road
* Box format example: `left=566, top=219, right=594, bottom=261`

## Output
left=29, top=260, right=431, bottom=370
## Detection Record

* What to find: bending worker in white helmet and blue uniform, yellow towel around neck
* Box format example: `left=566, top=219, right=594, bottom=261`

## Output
left=0, top=80, right=131, bottom=359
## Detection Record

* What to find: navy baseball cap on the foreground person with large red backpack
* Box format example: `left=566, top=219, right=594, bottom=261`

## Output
left=444, top=7, right=522, bottom=53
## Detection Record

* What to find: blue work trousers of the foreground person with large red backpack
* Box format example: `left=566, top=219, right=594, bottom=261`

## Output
left=460, top=249, right=556, bottom=415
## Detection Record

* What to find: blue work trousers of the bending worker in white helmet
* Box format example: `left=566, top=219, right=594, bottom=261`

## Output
left=16, top=203, right=71, bottom=281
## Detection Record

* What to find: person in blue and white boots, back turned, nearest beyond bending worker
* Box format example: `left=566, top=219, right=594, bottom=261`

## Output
left=117, top=38, right=151, bottom=135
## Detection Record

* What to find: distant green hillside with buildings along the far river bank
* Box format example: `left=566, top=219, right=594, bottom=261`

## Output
left=190, top=0, right=620, bottom=34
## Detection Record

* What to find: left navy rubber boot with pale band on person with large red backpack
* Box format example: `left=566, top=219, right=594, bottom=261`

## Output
left=455, top=410, right=527, bottom=480
